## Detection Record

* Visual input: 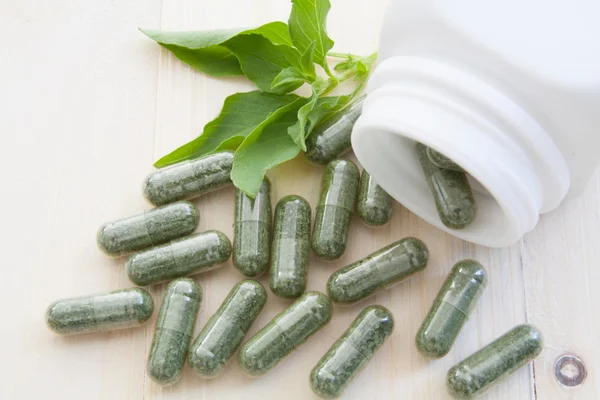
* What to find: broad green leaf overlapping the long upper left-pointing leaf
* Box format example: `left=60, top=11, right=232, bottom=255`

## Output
left=224, top=35, right=302, bottom=91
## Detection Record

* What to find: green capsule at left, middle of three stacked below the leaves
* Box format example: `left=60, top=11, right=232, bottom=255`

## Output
left=97, top=201, right=200, bottom=256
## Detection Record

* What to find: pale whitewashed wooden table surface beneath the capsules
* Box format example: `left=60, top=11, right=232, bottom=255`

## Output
left=0, top=0, right=600, bottom=400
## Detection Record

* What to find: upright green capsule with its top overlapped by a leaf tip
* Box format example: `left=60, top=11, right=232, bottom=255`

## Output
left=233, top=178, right=273, bottom=278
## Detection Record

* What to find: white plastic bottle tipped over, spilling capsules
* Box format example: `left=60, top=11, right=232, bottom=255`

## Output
left=352, top=0, right=600, bottom=247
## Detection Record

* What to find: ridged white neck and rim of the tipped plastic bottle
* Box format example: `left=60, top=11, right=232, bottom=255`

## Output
left=352, top=57, right=569, bottom=247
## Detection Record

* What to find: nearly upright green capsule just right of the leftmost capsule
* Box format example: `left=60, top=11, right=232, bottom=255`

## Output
left=146, top=278, right=202, bottom=385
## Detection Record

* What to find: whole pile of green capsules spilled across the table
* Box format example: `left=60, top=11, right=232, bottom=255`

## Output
left=46, top=99, right=542, bottom=398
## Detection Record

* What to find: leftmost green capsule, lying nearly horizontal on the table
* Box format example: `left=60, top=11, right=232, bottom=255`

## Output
left=46, top=288, right=154, bottom=335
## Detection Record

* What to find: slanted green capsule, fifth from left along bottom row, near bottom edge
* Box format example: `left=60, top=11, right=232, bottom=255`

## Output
left=310, top=306, right=394, bottom=399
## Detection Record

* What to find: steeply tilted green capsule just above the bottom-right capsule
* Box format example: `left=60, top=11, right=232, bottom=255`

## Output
left=416, top=260, right=487, bottom=358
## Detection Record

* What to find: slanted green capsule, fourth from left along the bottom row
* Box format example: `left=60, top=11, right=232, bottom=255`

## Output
left=238, top=292, right=333, bottom=376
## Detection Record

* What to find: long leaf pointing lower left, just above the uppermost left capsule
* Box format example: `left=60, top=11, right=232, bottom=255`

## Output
left=154, top=91, right=303, bottom=168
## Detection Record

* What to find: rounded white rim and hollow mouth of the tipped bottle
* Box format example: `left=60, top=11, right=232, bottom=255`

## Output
left=352, top=93, right=541, bottom=247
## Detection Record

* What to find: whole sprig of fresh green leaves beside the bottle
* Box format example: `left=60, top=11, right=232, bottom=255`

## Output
left=140, top=0, right=377, bottom=197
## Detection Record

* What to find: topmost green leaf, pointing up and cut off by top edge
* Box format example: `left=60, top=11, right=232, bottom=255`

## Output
left=288, top=0, right=333, bottom=71
